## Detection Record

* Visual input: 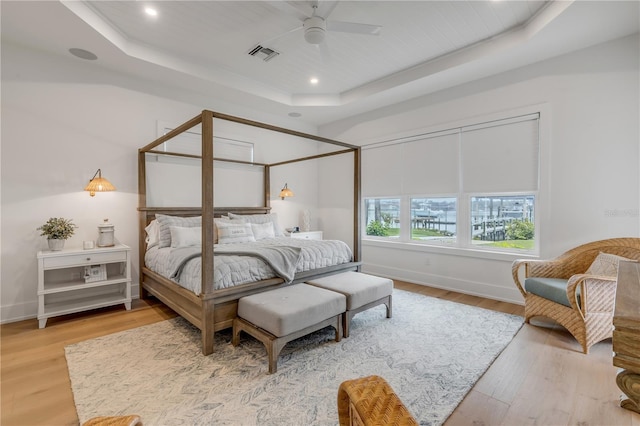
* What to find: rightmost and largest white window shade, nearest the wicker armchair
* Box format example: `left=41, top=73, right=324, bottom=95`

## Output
left=461, top=114, right=538, bottom=192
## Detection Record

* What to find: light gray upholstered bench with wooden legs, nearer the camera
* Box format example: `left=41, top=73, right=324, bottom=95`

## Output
left=231, top=284, right=347, bottom=374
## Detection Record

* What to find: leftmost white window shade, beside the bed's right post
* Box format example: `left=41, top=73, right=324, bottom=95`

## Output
left=361, top=145, right=405, bottom=197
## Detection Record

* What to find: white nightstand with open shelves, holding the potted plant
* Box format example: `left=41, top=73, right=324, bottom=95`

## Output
left=38, top=244, right=131, bottom=328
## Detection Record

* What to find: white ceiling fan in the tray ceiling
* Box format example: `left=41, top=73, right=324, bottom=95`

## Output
left=268, top=0, right=382, bottom=45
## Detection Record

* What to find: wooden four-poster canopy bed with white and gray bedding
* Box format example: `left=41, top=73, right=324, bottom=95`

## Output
left=138, top=110, right=361, bottom=355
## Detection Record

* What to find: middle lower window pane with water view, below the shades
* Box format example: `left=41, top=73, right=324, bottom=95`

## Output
left=411, top=198, right=457, bottom=244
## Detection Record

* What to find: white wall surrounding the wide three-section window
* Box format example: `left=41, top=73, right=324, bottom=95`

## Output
left=320, top=34, right=640, bottom=303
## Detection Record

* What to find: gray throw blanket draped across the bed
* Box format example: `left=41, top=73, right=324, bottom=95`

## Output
left=169, top=246, right=302, bottom=283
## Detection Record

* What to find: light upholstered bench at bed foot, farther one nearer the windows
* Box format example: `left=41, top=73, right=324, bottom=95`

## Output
left=307, top=271, right=393, bottom=337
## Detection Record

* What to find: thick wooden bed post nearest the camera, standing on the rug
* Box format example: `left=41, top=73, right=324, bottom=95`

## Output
left=200, top=110, right=215, bottom=355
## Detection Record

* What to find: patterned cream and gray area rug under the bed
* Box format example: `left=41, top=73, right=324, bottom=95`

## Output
left=65, top=290, right=523, bottom=426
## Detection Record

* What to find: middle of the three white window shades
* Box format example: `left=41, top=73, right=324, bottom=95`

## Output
left=402, top=132, right=460, bottom=194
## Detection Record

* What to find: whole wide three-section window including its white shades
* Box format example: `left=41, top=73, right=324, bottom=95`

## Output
left=362, top=113, right=540, bottom=252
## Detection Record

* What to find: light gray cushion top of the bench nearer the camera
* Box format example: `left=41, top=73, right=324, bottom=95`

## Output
left=238, top=284, right=347, bottom=337
